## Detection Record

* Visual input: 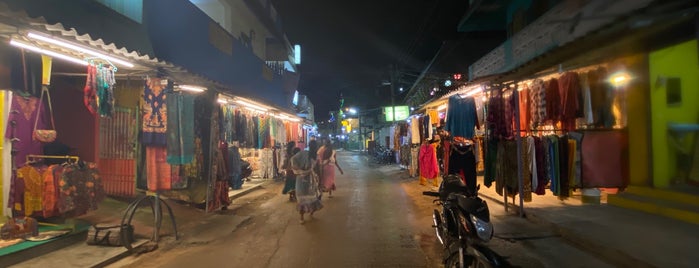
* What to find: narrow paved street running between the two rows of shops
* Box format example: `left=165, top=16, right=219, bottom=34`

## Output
left=112, top=152, right=608, bottom=267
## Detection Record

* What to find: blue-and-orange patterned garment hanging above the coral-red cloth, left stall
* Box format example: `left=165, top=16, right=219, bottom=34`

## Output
left=141, top=78, right=167, bottom=146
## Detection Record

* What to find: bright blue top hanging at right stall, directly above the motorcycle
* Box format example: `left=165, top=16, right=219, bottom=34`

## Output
left=448, top=95, right=480, bottom=139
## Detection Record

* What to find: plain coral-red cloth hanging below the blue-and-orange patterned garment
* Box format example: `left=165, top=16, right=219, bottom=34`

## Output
left=146, top=146, right=172, bottom=191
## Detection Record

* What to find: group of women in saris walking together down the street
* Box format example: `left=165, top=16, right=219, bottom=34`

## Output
left=282, top=139, right=344, bottom=224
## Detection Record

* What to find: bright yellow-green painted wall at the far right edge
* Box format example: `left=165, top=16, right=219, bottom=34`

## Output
left=652, top=40, right=699, bottom=188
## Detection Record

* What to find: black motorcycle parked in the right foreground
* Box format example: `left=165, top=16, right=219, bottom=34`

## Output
left=422, top=175, right=509, bottom=268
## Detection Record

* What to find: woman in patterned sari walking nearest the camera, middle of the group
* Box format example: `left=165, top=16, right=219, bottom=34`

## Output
left=291, top=151, right=323, bottom=224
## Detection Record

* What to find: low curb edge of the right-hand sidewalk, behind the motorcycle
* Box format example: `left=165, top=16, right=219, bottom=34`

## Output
left=479, top=193, right=655, bottom=267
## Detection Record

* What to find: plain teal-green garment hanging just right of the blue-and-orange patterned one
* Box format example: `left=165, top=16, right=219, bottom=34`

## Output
left=167, top=93, right=196, bottom=165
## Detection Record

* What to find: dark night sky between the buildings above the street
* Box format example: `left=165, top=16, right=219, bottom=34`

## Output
left=272, top=0, right=468, bottom=120
